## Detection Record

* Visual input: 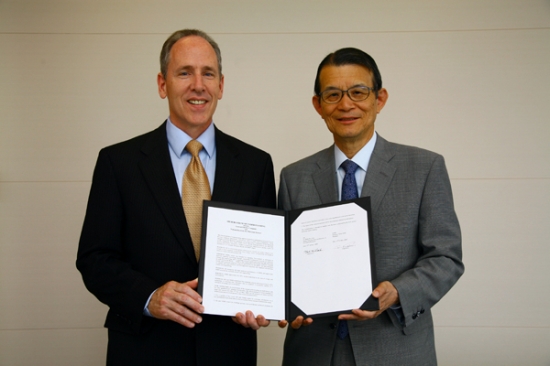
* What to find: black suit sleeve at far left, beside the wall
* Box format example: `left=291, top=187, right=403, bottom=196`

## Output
left=76, top=151, right=157, bottom=331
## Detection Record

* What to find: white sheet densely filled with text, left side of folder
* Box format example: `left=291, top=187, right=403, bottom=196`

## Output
left=200, top=207, right=285, bottom=320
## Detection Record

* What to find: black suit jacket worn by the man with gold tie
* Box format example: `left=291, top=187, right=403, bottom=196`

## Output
left=77, top=122, right=275, bottom=366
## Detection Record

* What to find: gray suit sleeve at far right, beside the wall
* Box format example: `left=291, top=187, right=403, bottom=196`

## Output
left=391, top=155, right=464, bottom=326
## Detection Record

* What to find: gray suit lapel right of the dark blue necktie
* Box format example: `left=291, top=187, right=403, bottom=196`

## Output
left=361, top=135, right=395, bottom=212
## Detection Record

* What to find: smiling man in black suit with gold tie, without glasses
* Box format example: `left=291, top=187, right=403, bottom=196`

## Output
left=77, top=30, right=275, bottom=366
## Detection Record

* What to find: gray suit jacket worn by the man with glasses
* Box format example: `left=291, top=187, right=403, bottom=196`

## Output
left=279, top=136, right=464, bottom=366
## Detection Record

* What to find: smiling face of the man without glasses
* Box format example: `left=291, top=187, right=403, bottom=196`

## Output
left=157, top=36, right=223, bottom=138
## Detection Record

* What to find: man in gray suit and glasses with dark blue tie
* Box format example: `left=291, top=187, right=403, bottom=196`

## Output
left=279, top=48, right=464, bottom=366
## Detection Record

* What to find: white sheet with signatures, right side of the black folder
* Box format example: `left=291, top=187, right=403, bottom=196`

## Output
left=291, top=203, right=372, bottom=315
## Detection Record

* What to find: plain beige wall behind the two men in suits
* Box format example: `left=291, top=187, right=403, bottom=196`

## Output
left=0, top=0, right=550, bottom=365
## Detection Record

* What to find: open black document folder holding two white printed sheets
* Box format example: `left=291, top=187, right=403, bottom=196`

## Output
left=198, top=197, right=379, bottom=320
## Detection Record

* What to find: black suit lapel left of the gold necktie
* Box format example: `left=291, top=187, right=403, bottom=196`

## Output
left=140, top=122, right=196, bottom=263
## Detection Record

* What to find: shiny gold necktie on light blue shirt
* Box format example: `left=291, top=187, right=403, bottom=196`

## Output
left=182, top=140, right=211, bottom=261
